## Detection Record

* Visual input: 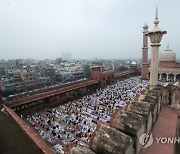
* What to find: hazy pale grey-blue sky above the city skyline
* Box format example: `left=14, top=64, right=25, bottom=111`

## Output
left=0, top=0, right=180, bottom=59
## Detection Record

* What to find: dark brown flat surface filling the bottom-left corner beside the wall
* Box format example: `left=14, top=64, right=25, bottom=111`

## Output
left=0, top=111, right=42, bottom=154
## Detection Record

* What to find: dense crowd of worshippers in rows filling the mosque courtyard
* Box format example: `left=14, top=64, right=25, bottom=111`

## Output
left=27, top=77, right=148, bottom=153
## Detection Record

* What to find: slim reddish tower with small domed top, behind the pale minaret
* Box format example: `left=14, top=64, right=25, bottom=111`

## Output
left=141, top=23, right=149, bottom=80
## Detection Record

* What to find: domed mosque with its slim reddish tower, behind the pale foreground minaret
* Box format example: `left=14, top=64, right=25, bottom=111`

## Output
left=141, top=24, right=180, bottom=81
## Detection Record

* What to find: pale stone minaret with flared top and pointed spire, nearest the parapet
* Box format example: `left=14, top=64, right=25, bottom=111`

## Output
left=148, top=8, right=167, bottom=88
